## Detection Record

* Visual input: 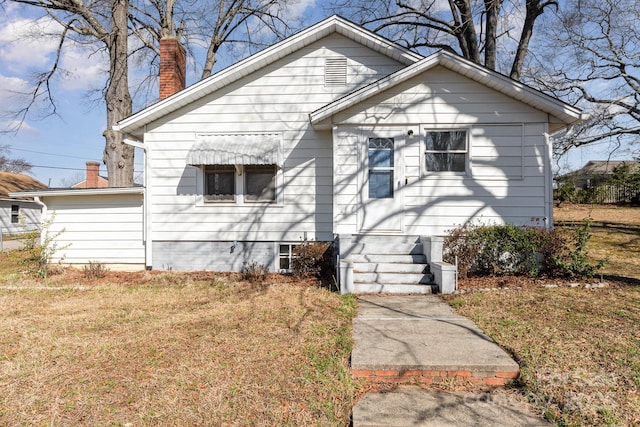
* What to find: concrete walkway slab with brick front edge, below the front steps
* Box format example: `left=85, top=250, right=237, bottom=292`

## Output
left=351, top=295, right=519, bottom=386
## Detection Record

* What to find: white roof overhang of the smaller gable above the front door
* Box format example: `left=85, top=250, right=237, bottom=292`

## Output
left=309, top=51, right=586, bottom=131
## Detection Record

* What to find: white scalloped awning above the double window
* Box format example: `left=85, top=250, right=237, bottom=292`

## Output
left=187, top=133, right=284, bottom=168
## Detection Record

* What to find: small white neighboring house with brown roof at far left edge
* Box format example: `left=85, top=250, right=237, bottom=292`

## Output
left=0, top=172, right=47, bottom=234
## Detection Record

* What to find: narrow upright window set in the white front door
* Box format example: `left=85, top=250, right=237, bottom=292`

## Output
left=367, top=138, right=394, bottom=199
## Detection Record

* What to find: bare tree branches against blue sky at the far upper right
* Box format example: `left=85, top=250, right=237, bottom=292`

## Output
left=527, top=0, right=640, bottom=154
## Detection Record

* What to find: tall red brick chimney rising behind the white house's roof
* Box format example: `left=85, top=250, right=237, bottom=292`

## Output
left=160, top=37, right=187, bottom=100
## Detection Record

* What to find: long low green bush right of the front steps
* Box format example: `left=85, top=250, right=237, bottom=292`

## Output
left=444, top=223, right=604, bottom=278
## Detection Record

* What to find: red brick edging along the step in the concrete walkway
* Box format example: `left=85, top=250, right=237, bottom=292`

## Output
left=351, top=369, right=520, bottom=386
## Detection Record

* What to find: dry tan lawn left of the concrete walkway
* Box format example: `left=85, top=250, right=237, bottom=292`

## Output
left=0, top=255, right=357, bottom=426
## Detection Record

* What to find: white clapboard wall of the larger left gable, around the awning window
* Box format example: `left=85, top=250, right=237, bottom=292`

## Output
left=144, top=34, right=401, bottom=270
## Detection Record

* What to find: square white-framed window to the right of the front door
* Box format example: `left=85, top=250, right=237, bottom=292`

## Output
left=425, top=130, right=467, bottom=172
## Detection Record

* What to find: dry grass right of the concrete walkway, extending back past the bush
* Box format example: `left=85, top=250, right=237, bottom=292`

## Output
left=446, top=205, right=640, bottom=426
